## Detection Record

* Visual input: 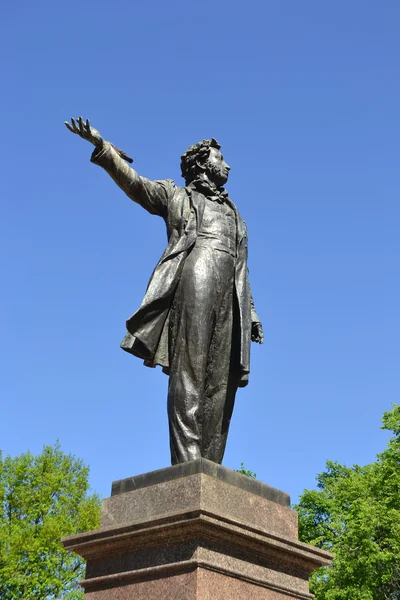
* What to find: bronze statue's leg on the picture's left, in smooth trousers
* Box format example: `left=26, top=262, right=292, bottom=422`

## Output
left=168, top=247, right=221, bottom=464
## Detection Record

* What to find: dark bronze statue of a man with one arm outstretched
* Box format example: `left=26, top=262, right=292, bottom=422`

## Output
left=66, top=117, right=263, bottom=464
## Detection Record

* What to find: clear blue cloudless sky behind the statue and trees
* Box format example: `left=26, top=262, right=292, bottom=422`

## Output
left=0, top=0, right=400, bottom=500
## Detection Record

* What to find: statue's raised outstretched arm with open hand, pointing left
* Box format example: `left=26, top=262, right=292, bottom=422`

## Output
left=65, top=117, right=175, bottom=217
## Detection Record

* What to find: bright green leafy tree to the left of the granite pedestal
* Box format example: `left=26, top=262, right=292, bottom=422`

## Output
left=0, top=443, right=100, bottom=600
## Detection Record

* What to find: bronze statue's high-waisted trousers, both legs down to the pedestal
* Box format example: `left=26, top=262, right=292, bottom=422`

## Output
left=168, top=243, right=238, bottom=464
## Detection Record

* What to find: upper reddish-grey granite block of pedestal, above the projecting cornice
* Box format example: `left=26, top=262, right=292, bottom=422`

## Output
left=101, top=459, right=297, bottom=538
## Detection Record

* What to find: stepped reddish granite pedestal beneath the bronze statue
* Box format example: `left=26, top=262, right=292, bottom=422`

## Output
left=63, top=459, right=332, bottom=600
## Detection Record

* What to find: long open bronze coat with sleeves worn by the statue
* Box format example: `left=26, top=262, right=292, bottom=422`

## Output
left=91, top=143, right=259, bottom=387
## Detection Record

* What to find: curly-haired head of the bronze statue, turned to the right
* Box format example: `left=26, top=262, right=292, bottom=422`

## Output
left=181, top=138, right=230, bottom=187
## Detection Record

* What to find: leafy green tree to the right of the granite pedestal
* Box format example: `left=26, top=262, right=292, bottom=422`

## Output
left=295, top=405, right=400, bottom=600
